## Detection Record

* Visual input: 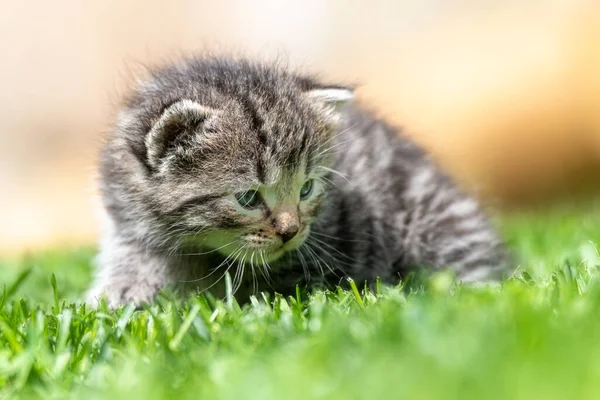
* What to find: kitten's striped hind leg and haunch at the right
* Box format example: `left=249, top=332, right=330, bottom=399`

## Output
left=398, top=168, right=508, bottom=282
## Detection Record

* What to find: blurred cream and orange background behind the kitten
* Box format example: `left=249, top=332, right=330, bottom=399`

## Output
left=0, top=0, right=600, bottom=253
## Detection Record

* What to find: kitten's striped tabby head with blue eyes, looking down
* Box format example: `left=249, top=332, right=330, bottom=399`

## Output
left=112, top=60, right=353, bottom=262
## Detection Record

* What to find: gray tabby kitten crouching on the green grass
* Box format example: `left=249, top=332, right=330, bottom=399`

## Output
left=89, top=57, right=507, bottom=306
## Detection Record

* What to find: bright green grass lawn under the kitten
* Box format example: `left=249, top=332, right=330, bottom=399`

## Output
left=0, top=207, right=600, bottom=400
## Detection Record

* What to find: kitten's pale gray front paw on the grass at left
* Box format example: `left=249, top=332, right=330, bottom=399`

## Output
left=87, top=237, right=168, bottom=307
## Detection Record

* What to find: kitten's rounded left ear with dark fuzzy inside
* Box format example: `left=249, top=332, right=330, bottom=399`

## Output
left=146, top=100, right=219, bottom=168
